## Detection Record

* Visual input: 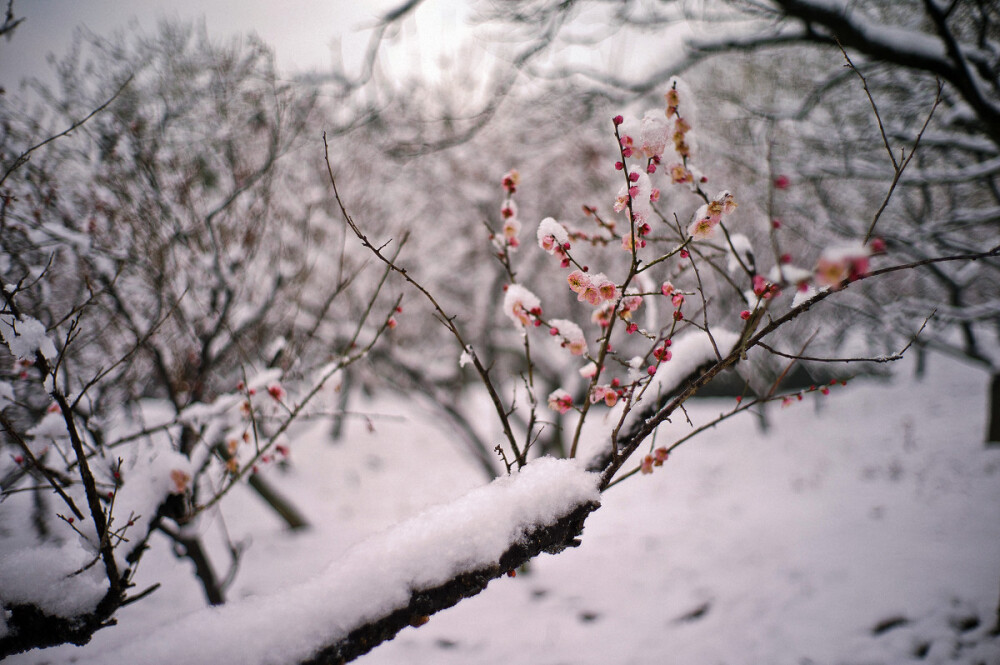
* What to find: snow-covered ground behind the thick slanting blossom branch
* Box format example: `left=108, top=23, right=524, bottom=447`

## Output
left=7, top=357, right=1000, bottom=665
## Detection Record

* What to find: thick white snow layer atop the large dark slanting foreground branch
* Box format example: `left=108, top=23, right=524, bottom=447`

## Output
left=80, top=458, right=600, bottom=665
